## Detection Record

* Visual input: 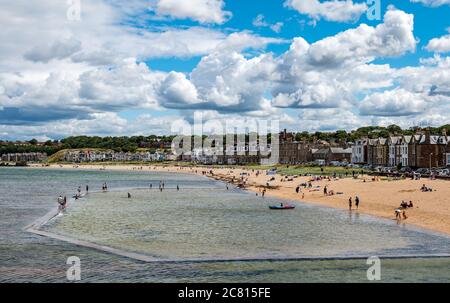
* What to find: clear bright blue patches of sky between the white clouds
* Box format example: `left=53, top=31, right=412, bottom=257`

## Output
left=147, top=0, right=450, bottom=67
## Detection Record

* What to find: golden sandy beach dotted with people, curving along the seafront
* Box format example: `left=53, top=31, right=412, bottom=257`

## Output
left=30, top=164, right=450, bottom=235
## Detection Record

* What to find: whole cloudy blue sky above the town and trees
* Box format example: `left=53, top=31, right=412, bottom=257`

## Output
left=0, top=0, right=450, bottom=141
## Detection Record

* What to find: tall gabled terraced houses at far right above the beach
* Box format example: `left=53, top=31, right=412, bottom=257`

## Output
left=352, top=130, right=450, bottom=168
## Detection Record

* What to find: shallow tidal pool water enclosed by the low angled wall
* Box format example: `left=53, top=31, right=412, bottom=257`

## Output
left=44, top=175, right=450, bottom=260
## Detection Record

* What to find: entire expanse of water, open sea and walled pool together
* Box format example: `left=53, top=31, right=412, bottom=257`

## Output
left=0, top=168, right=450, bottom=282
